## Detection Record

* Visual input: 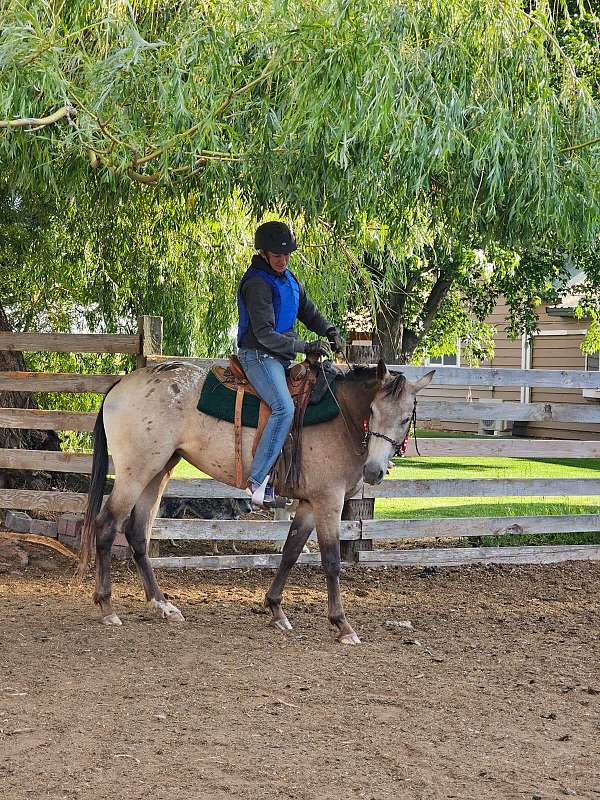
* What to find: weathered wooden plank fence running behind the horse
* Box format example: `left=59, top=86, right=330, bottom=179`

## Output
left=0, top=324, right=600, bottom=569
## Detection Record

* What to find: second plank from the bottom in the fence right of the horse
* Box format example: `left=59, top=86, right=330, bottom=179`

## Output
left=362, top=514, right=600, bottom=539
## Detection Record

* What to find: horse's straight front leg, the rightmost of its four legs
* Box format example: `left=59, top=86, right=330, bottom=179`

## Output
left=313, top=494, right=360, bottom=644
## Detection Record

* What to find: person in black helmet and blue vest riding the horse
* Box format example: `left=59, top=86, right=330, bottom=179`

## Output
left=237, top=222, right=344, bottom=508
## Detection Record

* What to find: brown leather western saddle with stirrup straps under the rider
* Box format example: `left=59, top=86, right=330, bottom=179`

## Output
left=212, top=355, right=318, bottom=489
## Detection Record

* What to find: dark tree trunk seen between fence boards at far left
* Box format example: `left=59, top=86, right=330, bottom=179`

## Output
left=0, top=306, right=60, bottom=489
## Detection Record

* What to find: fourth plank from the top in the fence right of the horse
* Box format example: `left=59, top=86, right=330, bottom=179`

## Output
left=364, top=478, right=600, bottom=497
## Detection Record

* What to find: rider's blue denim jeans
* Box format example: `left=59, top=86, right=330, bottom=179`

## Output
left=238, top=348, right=294, bottom=483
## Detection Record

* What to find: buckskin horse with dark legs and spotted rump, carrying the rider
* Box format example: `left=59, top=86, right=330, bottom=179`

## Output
left=78, top=360, right=435, bottom=644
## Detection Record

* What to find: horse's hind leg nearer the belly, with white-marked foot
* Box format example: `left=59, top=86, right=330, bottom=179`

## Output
left=125, top=456, right=184, bottom=622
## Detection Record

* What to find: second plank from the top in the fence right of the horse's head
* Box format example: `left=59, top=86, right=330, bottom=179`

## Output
left=417, top=400, right=600, bottom=424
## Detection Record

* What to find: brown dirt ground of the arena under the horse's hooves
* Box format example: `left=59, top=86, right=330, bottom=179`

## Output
left=0, top=546, right=600, bottom=800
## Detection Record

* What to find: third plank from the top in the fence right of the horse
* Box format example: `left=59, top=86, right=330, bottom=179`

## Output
left=406, top=436, right=600, bottom=458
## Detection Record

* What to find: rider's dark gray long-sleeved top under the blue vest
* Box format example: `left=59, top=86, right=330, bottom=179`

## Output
left=240, top=256, right=337, bottom=361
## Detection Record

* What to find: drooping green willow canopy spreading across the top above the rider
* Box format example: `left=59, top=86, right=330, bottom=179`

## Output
left=0, top=0, right=600, bottom=357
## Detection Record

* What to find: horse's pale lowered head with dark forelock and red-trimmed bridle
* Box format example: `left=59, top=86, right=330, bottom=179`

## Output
left=363, top=360, right=435, bottom=484
